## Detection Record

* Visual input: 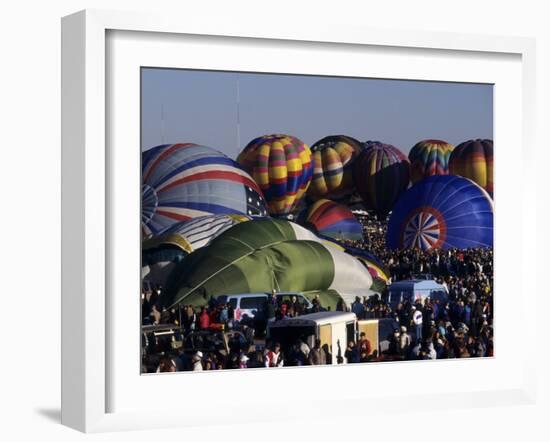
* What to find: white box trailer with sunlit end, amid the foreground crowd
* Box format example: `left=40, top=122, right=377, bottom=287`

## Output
left=267, top=312, right=357, bottom=365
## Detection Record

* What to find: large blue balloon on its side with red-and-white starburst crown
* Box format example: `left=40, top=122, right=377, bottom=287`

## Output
left=386, top=175, right=493, bottom=250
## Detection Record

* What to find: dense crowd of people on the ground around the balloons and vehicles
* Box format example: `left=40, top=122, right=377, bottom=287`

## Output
left=142, top=212, right=493, bottom=373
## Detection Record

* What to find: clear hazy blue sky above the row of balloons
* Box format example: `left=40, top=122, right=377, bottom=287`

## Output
left=141, top=69, right=493, bottom=158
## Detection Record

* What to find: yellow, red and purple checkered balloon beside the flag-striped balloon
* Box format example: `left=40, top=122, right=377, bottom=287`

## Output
left=237, top=135, right=313, bottom=215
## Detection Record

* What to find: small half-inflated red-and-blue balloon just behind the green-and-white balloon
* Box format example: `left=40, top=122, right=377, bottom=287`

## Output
left=298, top=199, right=363, bottom=241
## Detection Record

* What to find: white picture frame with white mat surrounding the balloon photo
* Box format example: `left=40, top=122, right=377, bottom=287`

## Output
left=62, top=10, right=536, bottom=432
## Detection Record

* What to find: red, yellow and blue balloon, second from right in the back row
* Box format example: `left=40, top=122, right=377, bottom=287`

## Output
left=409, top=140, right=454, bottom=184
